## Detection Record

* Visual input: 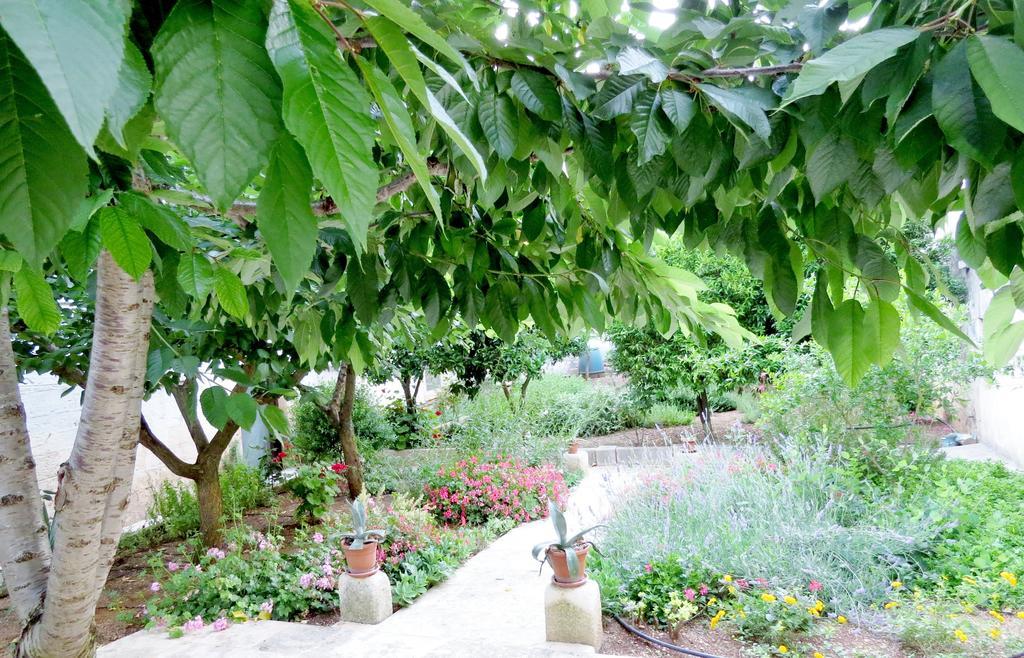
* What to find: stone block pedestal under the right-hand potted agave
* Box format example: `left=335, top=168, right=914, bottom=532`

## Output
left=544, top=580, right=604, bottom=650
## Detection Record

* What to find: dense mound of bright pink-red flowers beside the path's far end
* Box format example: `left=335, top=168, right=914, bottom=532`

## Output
left=426, top=456, right=567, bottom=525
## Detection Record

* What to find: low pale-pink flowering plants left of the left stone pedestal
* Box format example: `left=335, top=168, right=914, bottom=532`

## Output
left=145, top=526, right=343, bottom=632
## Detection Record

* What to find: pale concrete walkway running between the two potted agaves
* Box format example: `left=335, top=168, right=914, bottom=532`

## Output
left=99, top=469, right=614, bottom=658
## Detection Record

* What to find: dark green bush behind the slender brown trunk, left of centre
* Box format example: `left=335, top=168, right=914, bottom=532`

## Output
left=292, top=384, right=397, bottom=462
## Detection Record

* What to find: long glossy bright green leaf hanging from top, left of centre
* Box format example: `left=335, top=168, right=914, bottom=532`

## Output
left=266, top=0, right=378, bottom=251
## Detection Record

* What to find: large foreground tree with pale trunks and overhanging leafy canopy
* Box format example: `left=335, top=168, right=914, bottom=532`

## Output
left=0, top=0, right=1024, bottom=656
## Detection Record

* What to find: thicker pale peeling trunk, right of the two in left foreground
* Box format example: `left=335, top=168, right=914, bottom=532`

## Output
left=14, top=251, right=153, bottom=658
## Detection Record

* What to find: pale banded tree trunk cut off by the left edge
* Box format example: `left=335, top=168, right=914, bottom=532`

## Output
left=0, top=307, right=50, bottom=625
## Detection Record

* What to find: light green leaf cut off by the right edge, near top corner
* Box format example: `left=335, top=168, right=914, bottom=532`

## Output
left=967, top=35, right=1024, bottom=132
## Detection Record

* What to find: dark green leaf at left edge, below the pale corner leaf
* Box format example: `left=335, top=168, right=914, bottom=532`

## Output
left=0, top=30, right=88, bottom=266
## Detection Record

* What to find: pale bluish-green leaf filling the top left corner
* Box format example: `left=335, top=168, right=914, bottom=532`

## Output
left=0, top=0, right=130, bottom=155
